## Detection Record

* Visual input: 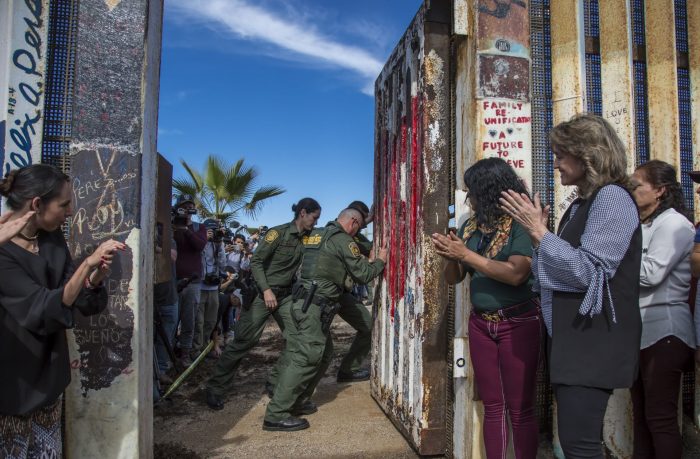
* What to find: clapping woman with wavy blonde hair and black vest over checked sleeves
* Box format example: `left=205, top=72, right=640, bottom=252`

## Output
left=501, top=114, right=642, bottom=458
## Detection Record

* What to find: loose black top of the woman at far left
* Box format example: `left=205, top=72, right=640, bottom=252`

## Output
left=0, top=230, right=107, bottom=415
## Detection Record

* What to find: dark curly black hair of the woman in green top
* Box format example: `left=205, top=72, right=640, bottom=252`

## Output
left=464, top=158, right=529, bottom=227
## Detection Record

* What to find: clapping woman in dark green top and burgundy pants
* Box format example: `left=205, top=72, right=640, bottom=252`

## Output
left=432, top=158, right=542, bottom=459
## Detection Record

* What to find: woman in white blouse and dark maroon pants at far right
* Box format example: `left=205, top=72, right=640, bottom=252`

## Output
left=631, top=160, right=695, bottom=459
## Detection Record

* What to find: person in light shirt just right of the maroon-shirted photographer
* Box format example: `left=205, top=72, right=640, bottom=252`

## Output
left=193, top=219, right=226, bottom=355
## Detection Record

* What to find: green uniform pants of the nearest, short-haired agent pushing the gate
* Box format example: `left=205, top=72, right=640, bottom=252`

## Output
left=265, top=299, right=332, bottom=422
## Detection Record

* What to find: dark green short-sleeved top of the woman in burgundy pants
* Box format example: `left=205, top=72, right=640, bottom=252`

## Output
left=458, top=222, right=535, bottom=311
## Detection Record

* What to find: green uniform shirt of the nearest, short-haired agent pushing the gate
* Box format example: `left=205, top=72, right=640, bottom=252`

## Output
left=301, top=221, right=384, bottom=301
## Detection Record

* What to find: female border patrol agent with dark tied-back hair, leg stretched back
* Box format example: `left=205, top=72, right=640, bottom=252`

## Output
left=207, top=198, right=321, bottom=410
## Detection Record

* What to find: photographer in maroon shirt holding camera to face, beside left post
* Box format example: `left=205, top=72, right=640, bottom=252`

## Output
left=173, top=194, right=207, bottom=366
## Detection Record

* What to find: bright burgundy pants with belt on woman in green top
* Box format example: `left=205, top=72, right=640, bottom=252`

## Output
left=469, top=309, right=542, bottom=459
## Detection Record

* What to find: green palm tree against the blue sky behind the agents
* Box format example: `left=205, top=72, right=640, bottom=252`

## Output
left=173, top=155, right=286, bottom=224
